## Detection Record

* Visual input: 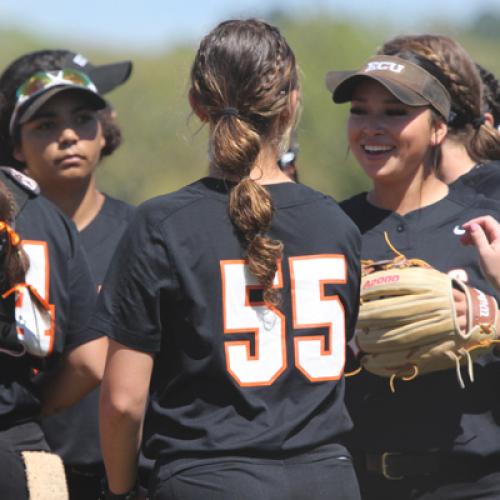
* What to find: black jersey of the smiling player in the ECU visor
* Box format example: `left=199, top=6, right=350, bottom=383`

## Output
left=341, top=192, right=500, bottom=456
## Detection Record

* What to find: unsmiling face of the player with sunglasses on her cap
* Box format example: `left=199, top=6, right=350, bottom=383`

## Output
left=14, top=91, right=105, bottom=191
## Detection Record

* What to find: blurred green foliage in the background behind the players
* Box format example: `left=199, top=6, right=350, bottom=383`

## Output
left=0, top=13, right=500, bottom=203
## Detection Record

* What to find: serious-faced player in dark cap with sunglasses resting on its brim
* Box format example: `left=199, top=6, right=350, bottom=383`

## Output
left=0, top=50, right=132, bottom=500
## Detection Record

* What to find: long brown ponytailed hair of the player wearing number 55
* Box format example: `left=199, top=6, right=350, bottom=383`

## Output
left=190, top=19, right=299, bottom=304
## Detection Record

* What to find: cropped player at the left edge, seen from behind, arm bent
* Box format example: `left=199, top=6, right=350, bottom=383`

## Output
left=0, top=168, right=107, bottom=500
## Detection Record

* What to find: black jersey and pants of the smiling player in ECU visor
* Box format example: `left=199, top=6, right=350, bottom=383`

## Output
left=341, top=190, right=500, bottom=500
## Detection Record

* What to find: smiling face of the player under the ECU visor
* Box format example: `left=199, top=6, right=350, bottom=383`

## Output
left=347, top=79, right=446, bottom=184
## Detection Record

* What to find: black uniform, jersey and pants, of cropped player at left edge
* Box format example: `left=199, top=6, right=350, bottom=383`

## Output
left=0, top=169, right=98, bottom=500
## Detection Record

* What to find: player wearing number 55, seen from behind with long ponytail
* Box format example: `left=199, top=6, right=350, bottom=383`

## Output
left=93, top=19, right=359, bottom=500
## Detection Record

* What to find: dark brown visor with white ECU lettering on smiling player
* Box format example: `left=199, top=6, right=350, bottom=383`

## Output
left=326, top=55, right=451, bottom=121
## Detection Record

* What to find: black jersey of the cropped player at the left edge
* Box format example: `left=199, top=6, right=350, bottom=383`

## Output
left=0, top=170, right=98, bottom=429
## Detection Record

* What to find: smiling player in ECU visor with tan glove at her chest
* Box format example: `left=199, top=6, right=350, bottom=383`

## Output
left=327, top=50, right=500, bottom=500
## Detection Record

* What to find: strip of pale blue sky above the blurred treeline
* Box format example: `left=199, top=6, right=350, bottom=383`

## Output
left=0, top=0, right=500, bottom=51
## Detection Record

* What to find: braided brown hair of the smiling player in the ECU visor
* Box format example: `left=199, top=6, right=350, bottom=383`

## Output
left=379, top=35, right=500, bottom=162
